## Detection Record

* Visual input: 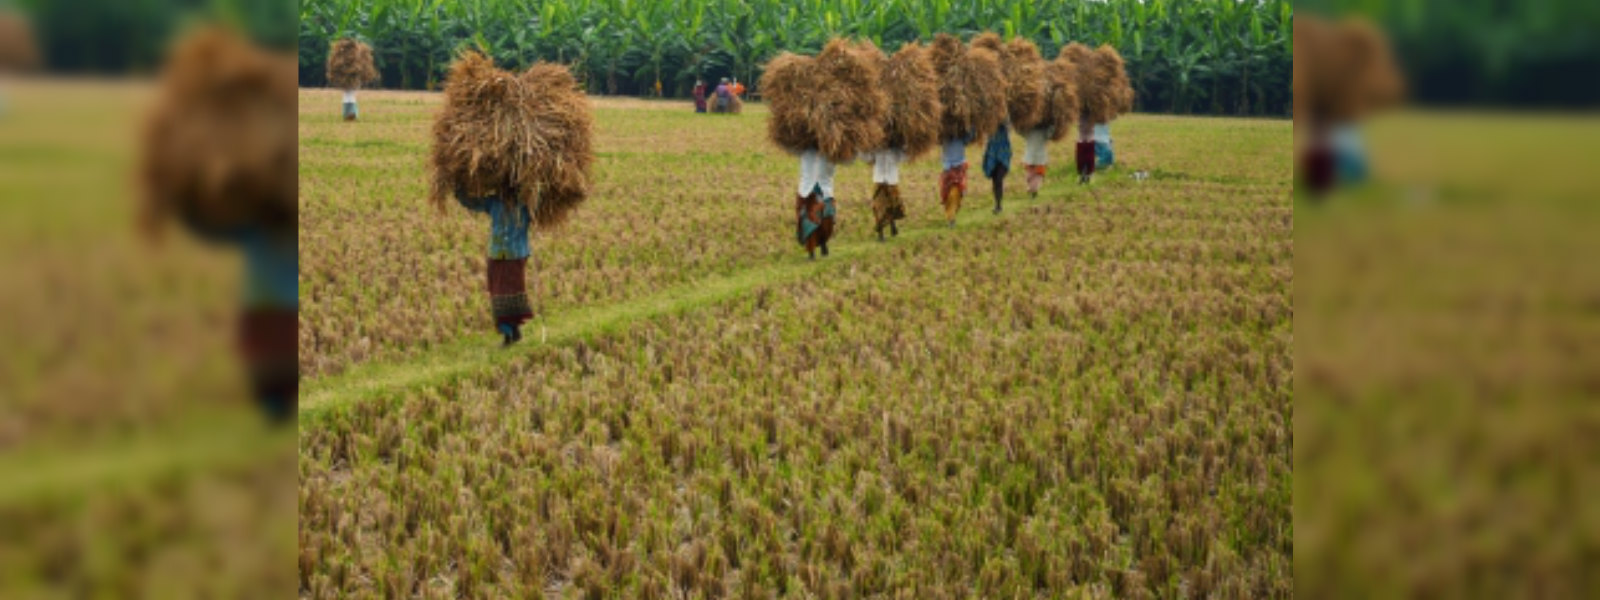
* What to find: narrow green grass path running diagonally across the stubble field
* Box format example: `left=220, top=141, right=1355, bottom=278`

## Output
left=299, top=188, right=1098, bottom=424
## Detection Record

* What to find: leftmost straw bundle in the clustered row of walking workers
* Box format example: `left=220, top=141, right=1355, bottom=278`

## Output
left=760, top=40, right=890, bottom=162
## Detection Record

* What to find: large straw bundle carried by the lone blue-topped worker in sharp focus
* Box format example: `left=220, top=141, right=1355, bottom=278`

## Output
left=430, top=51, right=594, bottom=229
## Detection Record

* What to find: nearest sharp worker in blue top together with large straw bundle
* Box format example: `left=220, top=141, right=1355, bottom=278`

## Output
left=429, top=51, right=594, bottom=346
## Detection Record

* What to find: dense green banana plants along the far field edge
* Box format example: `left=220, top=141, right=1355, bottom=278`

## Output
left=299, top=0, right=1293, bottom=115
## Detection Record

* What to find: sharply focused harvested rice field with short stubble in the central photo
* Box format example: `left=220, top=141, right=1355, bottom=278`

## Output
left=298, top=90, right=1294, bottom=598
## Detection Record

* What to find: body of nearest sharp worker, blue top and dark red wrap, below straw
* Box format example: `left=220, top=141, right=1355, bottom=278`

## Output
left=456, top=187, right=533, bottom=346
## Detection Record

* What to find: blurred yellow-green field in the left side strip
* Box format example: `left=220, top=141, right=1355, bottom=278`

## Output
left=0, top=78, right=296, bottom=598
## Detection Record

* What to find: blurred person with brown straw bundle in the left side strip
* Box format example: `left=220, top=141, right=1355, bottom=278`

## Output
left=139, top=29, right=299, bottom=424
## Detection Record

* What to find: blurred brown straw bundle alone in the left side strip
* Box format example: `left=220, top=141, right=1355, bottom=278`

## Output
left=139, top=29, right=299, bottom=232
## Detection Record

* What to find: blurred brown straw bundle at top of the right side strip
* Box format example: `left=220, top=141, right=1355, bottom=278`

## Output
left=1294, top=14, right=1405, bottom=127
